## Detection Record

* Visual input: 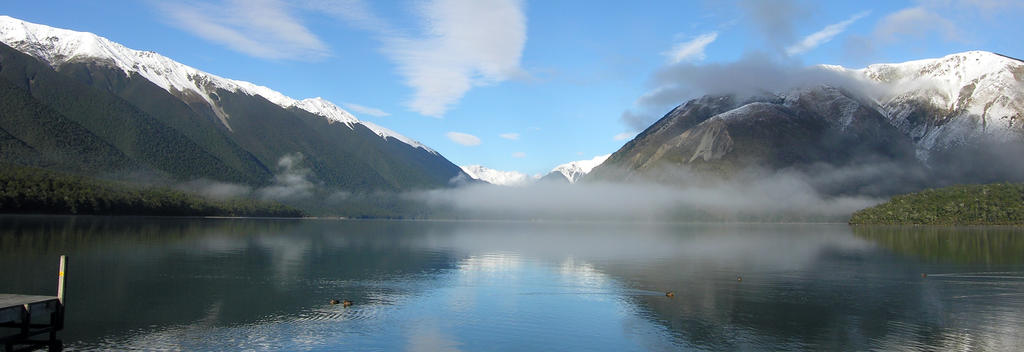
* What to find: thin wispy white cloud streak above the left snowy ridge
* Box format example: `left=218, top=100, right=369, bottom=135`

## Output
left=157, top=0, right=330, bottom=60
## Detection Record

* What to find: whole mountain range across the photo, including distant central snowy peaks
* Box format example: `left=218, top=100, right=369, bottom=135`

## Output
left=0, top=16, right=1024, bottom=200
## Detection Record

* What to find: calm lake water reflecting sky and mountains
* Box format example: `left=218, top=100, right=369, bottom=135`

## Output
left=0, top=217, right=1024, bottom=351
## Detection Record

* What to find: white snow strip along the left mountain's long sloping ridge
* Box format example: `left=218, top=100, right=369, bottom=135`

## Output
left=0, top=15, right=437, bottom=155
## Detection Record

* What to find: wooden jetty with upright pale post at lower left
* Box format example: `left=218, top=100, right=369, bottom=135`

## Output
left=0, top=256, right=68, bottom=352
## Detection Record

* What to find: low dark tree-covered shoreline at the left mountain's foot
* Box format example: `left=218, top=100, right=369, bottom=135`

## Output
left=0, top=164, right=304, bottom=217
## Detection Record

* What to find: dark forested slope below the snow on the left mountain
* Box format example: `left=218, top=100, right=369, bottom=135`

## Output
left=0, top=43, right=460, bottom=195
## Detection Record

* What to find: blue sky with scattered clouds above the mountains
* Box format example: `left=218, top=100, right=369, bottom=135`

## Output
left=0, top=0, right=1024, bottom=174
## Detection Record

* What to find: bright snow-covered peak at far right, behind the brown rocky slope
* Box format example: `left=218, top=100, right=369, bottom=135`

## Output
left=847, top=51, right=1024, bottom=160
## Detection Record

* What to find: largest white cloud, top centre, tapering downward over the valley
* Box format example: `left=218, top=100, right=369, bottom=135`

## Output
left=384, top=0, right=526, bottom=117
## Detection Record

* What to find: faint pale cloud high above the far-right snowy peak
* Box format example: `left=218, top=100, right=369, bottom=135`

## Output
left=874, top=6, right=959, bottom=42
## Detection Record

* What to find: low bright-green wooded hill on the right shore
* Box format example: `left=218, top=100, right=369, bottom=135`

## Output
left=850, top=183, right=1024, bottom=225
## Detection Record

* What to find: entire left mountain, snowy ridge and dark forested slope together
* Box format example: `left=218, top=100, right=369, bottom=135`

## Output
left=0, top=16, right=465, bottom=190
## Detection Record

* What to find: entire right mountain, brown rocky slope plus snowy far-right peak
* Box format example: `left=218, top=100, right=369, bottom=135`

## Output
left=588, top=51, right=1024, bottom=189
